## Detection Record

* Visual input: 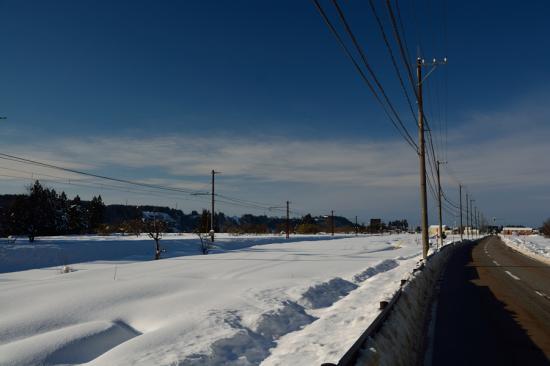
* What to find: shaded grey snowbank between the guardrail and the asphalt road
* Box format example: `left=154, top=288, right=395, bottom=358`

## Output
left=356, top=243, right=461, bottom=366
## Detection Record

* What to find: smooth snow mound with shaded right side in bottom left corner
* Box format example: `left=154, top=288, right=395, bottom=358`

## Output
left=0, top=321, right=141, bottom=366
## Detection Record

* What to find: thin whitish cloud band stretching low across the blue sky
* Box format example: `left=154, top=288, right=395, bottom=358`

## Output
left=0, top=93, right=550, bottom=224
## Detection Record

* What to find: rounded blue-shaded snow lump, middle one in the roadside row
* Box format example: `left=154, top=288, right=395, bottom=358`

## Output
left=298, top=277, right=357, bottom=309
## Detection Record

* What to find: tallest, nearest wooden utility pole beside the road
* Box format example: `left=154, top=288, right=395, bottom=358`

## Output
left=416, top=57, right=430, bottom=259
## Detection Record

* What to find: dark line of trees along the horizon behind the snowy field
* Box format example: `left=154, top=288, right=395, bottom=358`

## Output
left=0, top=180, right=414, bottom=242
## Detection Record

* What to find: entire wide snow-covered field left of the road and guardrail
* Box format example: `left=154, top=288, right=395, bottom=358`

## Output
left=0, top=234, right=421, bottom=365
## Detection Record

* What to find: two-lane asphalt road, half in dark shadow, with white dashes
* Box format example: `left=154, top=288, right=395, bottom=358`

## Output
left=432, top=236, right=550, bottom=366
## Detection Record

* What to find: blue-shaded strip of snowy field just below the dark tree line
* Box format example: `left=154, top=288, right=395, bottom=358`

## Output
left=0, top=234, right=344, bottom=273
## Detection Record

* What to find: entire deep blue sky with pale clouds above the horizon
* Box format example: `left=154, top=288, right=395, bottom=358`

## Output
left=0, top=0, right=550, bottom=225
